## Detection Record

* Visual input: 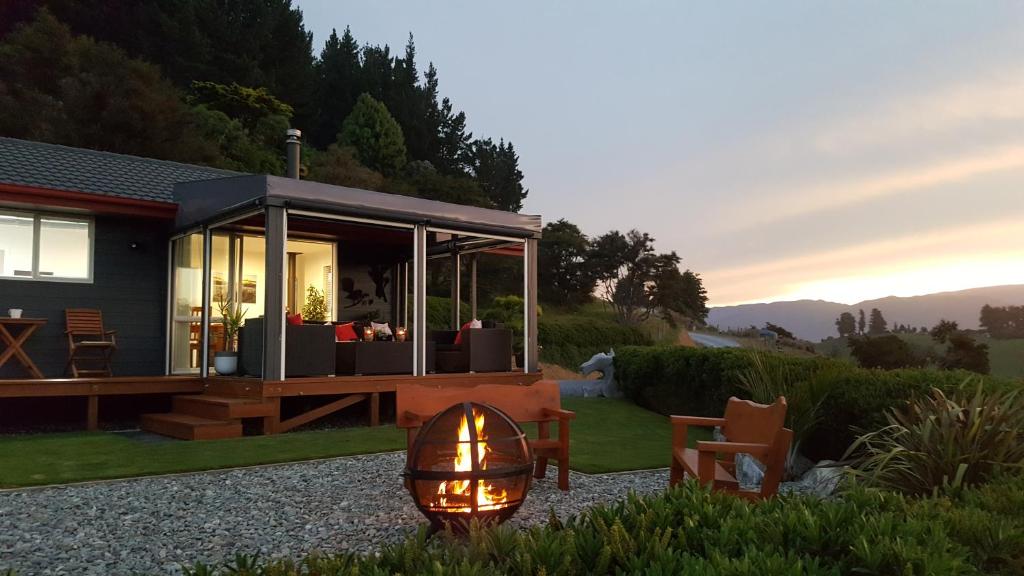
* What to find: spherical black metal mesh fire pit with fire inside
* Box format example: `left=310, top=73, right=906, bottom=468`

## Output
left=406, top=402, right=534, bottom=530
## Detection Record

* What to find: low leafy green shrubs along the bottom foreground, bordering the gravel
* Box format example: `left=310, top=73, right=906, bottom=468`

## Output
left=178, top=471, right=1024, bottom=576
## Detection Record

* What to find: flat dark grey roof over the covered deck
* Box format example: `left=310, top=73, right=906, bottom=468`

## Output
left=174, top=175, right=542, bottom=238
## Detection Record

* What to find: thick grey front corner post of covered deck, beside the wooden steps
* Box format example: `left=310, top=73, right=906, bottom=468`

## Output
left=263, top=206, right=288, bottom=380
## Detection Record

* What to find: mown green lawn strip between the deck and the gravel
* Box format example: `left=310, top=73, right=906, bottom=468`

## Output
left=0, top=398, right=706, bottom=488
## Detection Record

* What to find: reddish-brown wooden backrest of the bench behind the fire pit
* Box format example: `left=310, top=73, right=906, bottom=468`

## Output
left=395, top=380, right=561, bottom=428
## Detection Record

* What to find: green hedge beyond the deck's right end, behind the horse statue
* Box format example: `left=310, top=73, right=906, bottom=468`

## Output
left=537, top=315, right=653, bottom=369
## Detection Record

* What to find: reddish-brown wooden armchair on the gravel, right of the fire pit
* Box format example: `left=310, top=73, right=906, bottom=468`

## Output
left=669, top=397, right=793, bottom=499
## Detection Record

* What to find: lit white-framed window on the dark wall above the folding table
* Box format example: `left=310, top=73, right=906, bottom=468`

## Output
left=0, top=211, right=92, bottom=281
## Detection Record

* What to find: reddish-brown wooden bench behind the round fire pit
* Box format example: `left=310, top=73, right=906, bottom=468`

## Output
left=395, top=380, right=575, bottom=490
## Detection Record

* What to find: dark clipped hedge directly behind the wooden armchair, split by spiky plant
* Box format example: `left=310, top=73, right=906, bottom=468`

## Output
left=615, top=346, right=1010, bottom=459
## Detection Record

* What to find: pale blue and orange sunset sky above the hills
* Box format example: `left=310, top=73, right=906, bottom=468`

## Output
left=298, top=0, right=1024, bottom=305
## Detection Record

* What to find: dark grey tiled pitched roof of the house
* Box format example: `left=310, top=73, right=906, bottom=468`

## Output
left=0, top=137, right=241, bottom=203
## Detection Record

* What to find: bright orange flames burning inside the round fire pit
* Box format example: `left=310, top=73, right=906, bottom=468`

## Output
left=431, top=408, right=508, bottom=512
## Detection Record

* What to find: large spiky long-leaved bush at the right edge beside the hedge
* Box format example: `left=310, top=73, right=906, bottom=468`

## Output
left=847, top=380, right=1024, bottom=494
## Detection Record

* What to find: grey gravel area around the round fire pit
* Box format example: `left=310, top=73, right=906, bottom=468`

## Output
left=0, top=452, right=668, bottom=576
